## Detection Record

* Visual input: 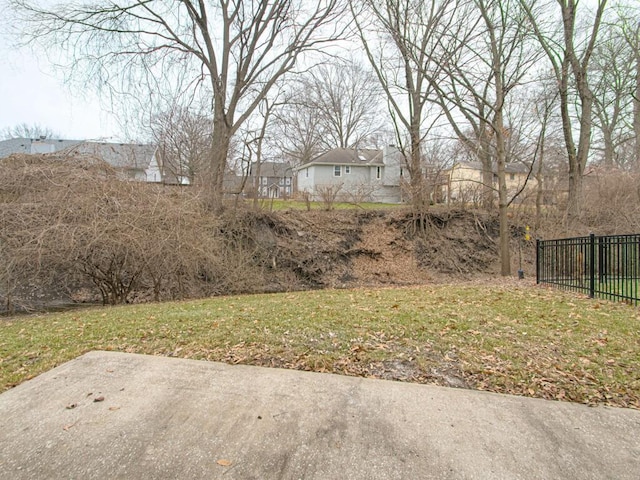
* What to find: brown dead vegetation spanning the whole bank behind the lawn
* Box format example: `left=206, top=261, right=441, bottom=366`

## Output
left=0, top=155, right=640, bottom=311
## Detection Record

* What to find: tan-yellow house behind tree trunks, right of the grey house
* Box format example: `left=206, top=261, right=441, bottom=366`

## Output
left=441, top=162, right=536, bottom=203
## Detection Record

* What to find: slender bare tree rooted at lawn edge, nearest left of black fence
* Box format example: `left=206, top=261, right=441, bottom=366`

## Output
left=424, top=0, right=539, bottom=275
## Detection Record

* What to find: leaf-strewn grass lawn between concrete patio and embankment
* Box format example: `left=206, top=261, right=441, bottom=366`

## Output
left=0, top=283, right=640, bottom=409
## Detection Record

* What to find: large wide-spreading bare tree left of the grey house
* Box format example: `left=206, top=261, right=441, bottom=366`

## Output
left=13, top=0, right=342, bottom=210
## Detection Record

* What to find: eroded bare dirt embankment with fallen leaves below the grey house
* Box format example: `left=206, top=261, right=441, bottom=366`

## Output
left=244, top=206, right=510, bottom=290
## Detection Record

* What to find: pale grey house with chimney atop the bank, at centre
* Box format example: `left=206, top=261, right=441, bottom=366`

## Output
left=294, top=146, right=408, bottom=203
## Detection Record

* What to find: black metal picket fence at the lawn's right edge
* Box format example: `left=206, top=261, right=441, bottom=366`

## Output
left=536, top=234, right=640, bottom=305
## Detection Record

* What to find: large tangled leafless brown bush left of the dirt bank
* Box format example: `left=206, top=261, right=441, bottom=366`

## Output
left=0, top=155, right=259, bottom=310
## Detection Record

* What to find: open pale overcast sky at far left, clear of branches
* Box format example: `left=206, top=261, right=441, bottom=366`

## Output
left=0, top=0, right=119, bottom=140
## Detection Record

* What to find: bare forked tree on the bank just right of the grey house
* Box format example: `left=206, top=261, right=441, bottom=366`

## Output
left=351, top=0, right=458, bottom=209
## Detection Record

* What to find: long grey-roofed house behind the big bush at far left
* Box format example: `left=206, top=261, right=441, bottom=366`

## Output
left=0, top=137, right=162, bottom=183
